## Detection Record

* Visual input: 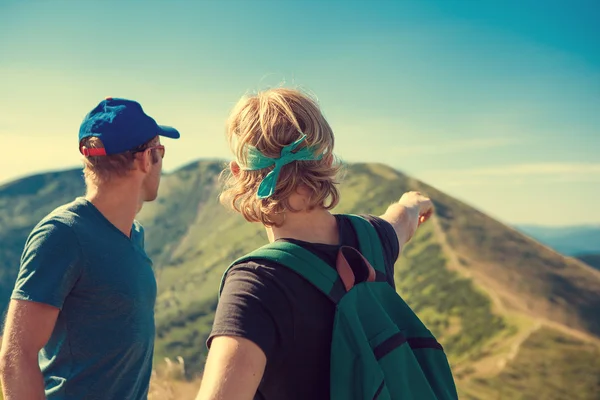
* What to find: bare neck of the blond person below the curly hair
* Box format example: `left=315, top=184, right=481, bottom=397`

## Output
left=267, top=208, right=340, bottom=245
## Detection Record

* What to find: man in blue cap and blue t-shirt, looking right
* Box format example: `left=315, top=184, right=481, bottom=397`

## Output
left=0, top=98, right=179, bottom=400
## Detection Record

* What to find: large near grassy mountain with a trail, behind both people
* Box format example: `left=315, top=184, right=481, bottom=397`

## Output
left=0, top=161, right=600, bottom=400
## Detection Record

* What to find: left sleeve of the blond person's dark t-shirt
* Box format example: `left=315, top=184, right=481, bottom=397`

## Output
left=207, top=263, right=293, bottom=360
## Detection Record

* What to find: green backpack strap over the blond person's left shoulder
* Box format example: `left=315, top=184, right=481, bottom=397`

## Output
left=219, top=242, right=346, bottom=304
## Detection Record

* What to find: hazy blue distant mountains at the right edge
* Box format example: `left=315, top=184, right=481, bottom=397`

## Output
left=516, top=225, right=600, bottom=256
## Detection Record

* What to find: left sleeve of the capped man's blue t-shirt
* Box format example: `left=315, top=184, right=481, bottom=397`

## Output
left=11, top=220, right=81, bottom=309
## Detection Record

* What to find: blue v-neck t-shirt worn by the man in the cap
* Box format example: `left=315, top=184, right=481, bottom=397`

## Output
left=12, top=198, right=156, bottom=400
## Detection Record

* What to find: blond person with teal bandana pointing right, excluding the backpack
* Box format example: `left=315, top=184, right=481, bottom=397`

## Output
left=198, top=89, right=448, bottom=400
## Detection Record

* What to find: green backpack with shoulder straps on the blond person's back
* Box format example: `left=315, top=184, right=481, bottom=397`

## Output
left=219, top=215, right=458, bottom=400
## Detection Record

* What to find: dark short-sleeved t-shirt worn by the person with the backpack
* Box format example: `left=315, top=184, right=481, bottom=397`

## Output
left=207, top=215, right=400, bottom=400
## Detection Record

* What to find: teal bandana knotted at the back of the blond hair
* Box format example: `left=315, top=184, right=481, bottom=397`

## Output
left=242, top=134, right=323, bottom=199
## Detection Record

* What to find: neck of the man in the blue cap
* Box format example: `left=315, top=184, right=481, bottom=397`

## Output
left=85, top=180, right=143, bottom=237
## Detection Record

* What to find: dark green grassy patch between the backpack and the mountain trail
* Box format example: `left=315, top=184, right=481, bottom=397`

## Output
left=395, top=219, right=507, bottom=363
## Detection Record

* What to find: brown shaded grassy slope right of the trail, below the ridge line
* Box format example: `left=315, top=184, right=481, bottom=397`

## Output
left=419, top=184, right=600, bottom=336
